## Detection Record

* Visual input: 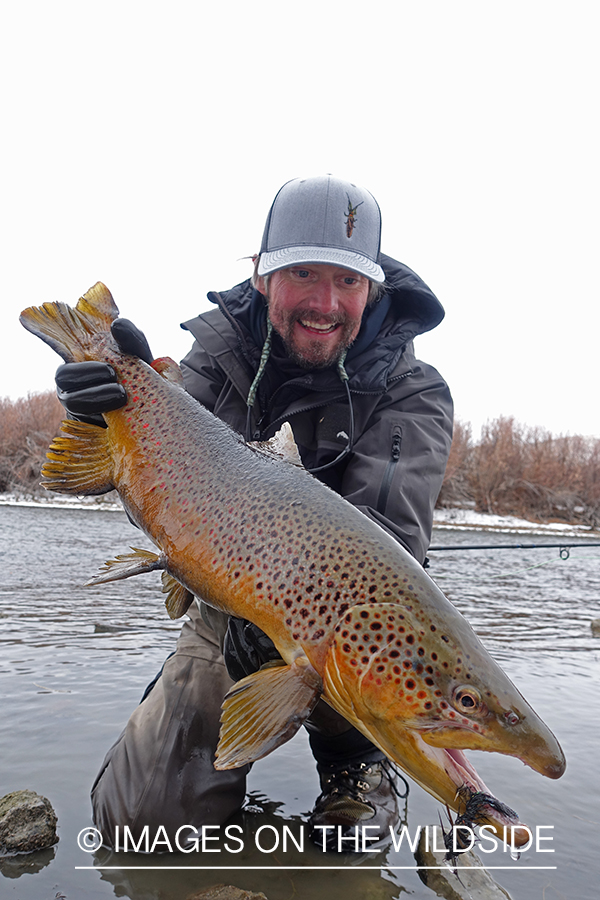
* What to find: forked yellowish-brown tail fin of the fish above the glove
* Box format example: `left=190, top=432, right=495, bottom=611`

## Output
left=19, top=281, right=119, bottom=362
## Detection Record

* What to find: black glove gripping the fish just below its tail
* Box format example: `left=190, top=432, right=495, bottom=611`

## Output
left=55, top=319, right=153, bottom=427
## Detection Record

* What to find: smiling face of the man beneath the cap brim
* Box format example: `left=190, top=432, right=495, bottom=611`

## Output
left=257, top=263, right=369, bottom=369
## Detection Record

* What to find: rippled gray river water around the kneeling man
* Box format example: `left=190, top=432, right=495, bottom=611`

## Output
left=0, top=506, right=600, bottom=900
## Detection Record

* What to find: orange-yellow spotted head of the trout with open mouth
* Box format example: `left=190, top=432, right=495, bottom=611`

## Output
left=324, top=598, right=565, bottom=846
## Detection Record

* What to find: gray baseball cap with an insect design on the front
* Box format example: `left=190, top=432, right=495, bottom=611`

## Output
left=258, top=175, right=385, bottom=282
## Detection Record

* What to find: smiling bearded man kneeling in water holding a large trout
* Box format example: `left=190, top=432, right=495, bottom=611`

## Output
left=57, top=175, right=452, bottom=843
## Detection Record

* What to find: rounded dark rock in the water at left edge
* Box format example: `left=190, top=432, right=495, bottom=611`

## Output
left=0, top=790, right=58, bottom=854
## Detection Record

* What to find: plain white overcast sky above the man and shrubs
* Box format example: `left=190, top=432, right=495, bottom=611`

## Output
left=0, top=0, right=600, bottom=435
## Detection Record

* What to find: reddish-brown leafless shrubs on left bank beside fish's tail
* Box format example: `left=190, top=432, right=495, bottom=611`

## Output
left=0, top=391, right=65, bottom=491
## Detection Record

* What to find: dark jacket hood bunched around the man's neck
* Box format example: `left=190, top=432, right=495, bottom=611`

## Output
left=192, top=254, right=444, bottom=392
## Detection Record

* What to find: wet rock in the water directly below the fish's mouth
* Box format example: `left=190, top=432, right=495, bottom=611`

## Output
left=415, top=826, right=511, bottom=900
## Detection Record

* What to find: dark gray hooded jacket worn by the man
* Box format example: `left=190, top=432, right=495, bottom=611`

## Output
left=182, top=256, right=452, bottom=562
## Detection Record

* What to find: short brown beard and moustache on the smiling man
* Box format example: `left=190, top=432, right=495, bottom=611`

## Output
left=271, top=310, right=361, bottom=369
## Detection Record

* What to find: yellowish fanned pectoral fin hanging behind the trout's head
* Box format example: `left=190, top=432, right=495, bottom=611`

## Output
left=215, top=657, right=323, bottom=769
